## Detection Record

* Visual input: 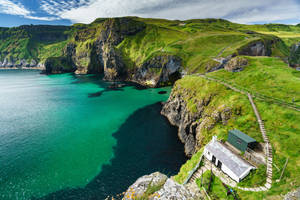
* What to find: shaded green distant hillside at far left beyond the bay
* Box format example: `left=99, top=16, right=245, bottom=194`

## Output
left=0, top=26, right=71, bottom=61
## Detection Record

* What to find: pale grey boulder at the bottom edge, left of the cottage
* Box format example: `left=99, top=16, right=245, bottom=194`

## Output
left=123, top=172, right=199, bottom=200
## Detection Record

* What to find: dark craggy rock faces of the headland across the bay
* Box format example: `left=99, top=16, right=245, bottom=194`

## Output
left=46, top=18, right=182, bottom=87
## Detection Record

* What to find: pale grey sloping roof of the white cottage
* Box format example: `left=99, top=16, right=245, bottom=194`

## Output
left=205, top=140, right=254, bottom=177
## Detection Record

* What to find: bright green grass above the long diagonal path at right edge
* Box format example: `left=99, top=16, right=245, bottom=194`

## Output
left=207, top=57, right=300, bottom=106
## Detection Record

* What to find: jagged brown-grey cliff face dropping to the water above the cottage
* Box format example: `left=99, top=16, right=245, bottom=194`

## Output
left=161, top=89, right=232, bottom=157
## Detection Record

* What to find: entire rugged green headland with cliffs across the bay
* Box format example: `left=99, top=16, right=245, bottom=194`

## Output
left=0, top=17, right=290, bottom=87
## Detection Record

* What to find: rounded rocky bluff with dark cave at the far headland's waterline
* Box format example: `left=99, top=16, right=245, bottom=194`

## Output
left=132, top=55, right=183, bottom=87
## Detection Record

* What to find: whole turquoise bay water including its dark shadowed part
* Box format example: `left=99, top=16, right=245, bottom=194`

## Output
left=0, top=70, right=185, bottom=200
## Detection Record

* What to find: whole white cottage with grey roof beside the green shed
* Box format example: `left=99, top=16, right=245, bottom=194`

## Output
left=204, top=136, right=255, bottom=182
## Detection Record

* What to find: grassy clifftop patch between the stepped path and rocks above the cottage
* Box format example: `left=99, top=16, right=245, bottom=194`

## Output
left=173, top=76, right=263, bottom=145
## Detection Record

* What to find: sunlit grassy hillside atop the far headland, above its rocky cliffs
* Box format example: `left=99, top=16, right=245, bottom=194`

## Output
left=118, top=18, right=289, bottom=73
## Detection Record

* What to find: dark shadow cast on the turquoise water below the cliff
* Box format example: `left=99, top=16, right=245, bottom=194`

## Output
left=34, top=103, right=186, bottom=200
